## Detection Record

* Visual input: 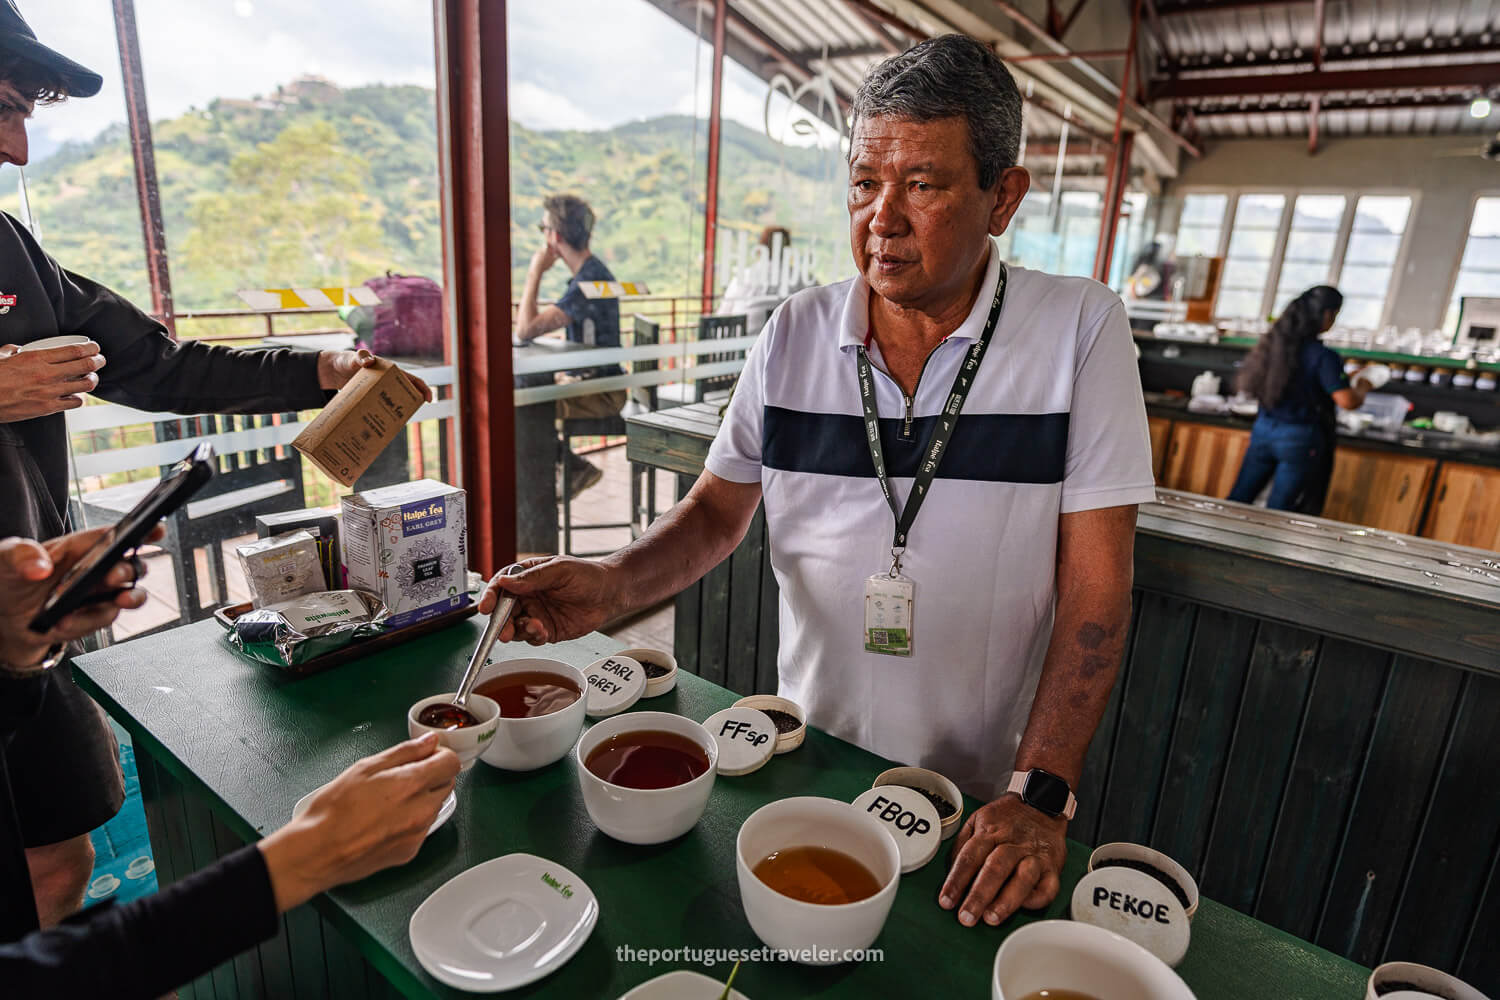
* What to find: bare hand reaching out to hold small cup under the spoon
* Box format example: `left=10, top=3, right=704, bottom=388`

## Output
left=260, top=733, right=459, bottom=913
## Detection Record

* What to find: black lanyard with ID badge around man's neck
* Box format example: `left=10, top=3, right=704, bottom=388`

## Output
left=858, top=264, right=1005, bottom=657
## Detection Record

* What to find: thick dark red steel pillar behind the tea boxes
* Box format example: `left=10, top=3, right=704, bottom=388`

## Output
left=434, top=0, right=516, bottom=576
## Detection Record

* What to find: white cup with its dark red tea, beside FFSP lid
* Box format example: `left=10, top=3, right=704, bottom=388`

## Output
left=578, top=712, right=719, bottom=844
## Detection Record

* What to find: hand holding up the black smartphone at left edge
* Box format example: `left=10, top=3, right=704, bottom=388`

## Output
left=0, top=525, right=165, bottom=669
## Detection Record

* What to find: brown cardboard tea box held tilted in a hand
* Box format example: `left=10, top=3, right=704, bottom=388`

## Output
left=291, top=358, right=423, bottom=486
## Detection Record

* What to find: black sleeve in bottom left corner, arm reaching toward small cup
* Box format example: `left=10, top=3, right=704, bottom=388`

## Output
left=0, top=844, right=279, bottom=999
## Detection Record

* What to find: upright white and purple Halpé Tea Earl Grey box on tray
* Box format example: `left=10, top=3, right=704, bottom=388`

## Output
left=342, top=480, right=470, bottom=628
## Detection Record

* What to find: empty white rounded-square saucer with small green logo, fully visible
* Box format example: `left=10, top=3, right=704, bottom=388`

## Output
left=407, top=855, right=599, bottom=993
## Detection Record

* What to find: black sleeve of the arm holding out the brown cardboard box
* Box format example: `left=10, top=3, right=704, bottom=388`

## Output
left=15, top=226, right=330, bottom=414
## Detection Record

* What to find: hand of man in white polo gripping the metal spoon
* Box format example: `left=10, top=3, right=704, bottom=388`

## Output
left=479, top=556, right=617, bottom=646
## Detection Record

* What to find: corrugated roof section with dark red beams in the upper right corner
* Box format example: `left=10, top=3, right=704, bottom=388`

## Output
left=1143, top=0, right=1500, bottom=142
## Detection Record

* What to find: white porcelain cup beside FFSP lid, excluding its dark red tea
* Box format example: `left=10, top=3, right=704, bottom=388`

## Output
left=578, top=712, right=719, bottom=844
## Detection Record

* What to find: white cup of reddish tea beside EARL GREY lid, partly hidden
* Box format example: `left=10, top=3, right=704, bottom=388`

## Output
left=474, top=657, right=588, bottom=771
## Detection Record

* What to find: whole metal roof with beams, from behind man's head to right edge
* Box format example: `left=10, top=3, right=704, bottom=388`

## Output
left=651, top=0, right=1500, bottom=167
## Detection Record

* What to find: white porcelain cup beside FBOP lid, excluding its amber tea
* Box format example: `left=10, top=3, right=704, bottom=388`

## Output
left=735, top=796, right=902, bottom=966
